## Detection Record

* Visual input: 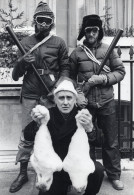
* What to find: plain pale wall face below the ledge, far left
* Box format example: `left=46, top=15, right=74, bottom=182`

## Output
left=0, top=97, right=22, bottom=151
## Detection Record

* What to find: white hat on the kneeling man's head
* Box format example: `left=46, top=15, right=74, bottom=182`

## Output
left=53, top=80, right=78, bottom=96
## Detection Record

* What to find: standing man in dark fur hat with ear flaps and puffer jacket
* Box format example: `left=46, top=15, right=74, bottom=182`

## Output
left=70, top=14, right=125, bottom=190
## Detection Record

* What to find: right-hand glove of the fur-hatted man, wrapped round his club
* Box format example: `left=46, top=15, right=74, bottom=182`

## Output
left=88, top=74, right=107, bottom=87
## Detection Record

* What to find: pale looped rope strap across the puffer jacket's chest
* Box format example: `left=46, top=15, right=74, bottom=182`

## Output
left=79, top=45, right=111, bottom=73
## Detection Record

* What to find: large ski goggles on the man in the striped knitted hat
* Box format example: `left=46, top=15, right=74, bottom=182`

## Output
left=35, top=16, right=53, bottom=26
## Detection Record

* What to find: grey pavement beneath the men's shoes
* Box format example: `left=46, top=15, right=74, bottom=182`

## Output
left=0, top=159, right=134, bottom=195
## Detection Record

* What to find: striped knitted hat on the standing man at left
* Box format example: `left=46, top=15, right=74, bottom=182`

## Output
left=34, top=1, right=54, bottom=18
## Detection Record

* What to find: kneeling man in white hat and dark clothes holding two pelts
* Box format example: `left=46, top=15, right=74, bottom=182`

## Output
left=24, top=79, right=104, bottom=195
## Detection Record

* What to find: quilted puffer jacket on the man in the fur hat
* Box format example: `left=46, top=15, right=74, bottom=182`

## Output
left=70, top=41, right=125, bottom=107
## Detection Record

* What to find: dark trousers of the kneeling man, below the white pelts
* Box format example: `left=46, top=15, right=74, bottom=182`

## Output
left=39, top=162, right=104, bottom=195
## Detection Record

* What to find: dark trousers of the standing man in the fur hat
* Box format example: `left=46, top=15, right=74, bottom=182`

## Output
left=97, top=113, right=121, bottom=179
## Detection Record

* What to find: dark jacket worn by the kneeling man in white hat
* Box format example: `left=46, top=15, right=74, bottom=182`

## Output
left=24, top=107, right=96, bottom=160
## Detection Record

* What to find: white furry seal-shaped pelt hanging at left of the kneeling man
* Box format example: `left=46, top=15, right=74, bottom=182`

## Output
left=30, top=105, right=62, bottom=191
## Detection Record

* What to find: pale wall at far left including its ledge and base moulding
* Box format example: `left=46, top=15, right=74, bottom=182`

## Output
left=0, top=87, right=22, bottom=162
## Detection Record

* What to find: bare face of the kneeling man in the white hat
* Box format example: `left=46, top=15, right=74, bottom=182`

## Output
left=55, top=91, right=76, bottom=114
